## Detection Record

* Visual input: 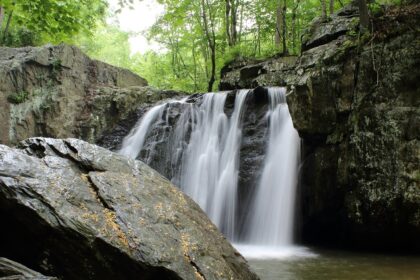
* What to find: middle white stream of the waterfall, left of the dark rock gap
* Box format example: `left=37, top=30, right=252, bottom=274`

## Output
left=180, top=90, right=249, bottom=239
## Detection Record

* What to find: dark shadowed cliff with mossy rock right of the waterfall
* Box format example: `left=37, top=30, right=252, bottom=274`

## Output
left=221, top=4, right=420, bottom=251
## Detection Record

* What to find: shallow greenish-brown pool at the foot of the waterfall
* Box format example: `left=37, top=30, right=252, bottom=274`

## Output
left=243, top=247, right=420, bottom=280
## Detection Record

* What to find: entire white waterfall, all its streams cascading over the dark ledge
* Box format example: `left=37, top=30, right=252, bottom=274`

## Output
left=120, top=88, right=312, bottom=257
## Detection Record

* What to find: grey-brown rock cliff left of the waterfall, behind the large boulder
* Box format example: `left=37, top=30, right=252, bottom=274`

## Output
left=0, top=45, right=183, bottom=144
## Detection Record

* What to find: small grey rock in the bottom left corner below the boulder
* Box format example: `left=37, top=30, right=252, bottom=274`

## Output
left=0, top=258, right=57, bottom=280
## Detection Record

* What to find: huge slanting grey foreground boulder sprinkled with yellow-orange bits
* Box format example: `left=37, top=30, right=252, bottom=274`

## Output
left=0, top=138, right=257, bottom=279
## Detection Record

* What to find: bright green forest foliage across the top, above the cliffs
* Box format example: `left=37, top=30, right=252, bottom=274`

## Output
left=0, top=0, right=401, bottom=92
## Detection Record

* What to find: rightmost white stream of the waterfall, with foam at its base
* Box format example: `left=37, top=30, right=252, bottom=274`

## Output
left=236, top=88, right=313, bottom=258
